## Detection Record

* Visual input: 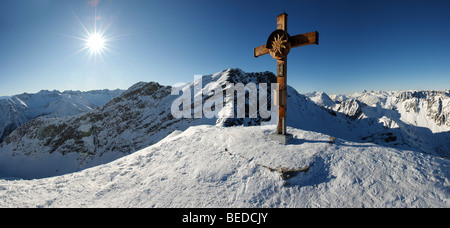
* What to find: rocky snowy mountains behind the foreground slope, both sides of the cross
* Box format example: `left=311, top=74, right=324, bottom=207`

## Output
left=0, top=69, right=450, bottom=179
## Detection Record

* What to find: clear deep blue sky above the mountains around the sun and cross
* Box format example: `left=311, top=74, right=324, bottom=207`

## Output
left=0, top=0, right=450, bottom=96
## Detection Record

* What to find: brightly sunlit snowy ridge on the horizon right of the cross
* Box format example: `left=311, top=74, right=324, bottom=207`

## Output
left=306, top=90, right=450, bottom=133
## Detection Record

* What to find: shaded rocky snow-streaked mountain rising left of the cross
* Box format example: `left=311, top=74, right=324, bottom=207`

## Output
left=0, top=69, right=275, bottom=178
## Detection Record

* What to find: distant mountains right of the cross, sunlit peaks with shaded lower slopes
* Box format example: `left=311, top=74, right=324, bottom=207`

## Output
left=309, top=90, right=450, bottom=157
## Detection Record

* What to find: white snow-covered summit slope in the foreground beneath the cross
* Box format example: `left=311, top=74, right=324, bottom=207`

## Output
left=0, top=125, right=450, bottom=207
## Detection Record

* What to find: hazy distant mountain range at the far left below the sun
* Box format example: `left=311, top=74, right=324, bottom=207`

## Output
left=0, top=90, right=123, bottom=143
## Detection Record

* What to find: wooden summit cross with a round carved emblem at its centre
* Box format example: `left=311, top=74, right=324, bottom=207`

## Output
left=253, top=13, right=319, bottom=144
